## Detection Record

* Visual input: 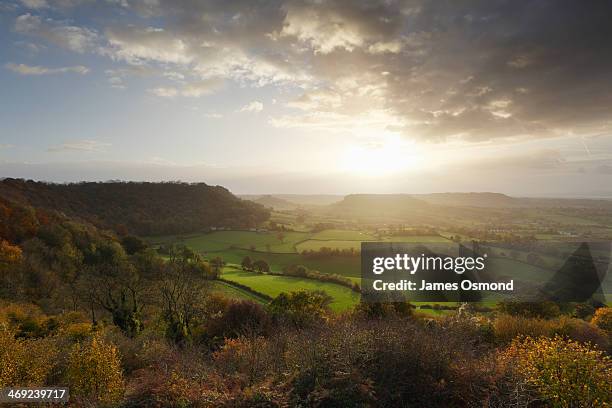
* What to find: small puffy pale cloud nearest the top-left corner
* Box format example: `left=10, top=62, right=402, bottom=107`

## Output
left=15, top=13, right=100, bottom=53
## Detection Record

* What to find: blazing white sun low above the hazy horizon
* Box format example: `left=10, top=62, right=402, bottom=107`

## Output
left=340, top=139, right=422, bottom=177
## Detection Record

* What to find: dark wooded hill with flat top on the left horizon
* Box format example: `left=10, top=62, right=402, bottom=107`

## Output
left=0, top=179, right=270, bottom=235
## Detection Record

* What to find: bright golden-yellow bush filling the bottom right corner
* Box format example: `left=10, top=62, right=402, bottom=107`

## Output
left=501, top=336, right=612, bottom=408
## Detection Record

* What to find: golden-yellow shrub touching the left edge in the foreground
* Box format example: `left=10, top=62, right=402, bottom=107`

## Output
left=0, top=327, right=58, bottom=388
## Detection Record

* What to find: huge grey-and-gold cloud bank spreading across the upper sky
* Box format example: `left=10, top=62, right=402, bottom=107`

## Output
left=7, top=0, right=612, bottom=143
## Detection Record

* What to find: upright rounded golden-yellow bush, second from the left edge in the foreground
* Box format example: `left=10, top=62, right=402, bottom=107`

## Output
left=67, top=336, right=124, bottom=403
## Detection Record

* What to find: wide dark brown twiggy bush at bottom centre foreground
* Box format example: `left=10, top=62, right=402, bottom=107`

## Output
left=285, top=317, right=488, bottom=407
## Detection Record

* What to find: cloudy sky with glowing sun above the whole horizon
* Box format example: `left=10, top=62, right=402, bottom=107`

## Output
left=0, top=0, right=612, bottom=198
